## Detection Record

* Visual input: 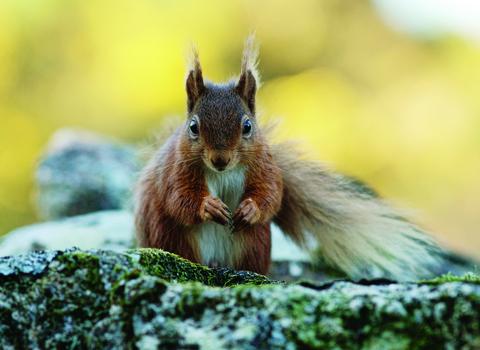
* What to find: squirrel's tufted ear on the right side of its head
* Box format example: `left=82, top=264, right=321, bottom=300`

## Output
left=235, top=34, right=259, bottom=114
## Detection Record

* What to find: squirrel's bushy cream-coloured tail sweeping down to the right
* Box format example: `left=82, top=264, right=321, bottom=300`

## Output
left=271, top=138, right=442, bottom=280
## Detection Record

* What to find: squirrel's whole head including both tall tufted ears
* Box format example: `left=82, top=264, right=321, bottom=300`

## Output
left=183, top=35, right=259, bottom=171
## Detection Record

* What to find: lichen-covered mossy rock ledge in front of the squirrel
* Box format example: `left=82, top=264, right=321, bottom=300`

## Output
left=0, top=249, right=480, bottom=350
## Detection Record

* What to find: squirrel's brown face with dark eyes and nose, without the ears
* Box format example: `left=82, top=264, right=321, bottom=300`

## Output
left=184, top=84, right=257, bottom=172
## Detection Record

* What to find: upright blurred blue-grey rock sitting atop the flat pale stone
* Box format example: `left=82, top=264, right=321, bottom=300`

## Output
left=35, top=129, right=140, bottom=220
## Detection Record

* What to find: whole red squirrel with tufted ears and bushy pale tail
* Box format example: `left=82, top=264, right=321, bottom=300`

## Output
left=135, top=36, right=441, bottom=280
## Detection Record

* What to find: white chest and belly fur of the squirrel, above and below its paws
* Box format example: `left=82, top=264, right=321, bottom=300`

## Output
left=197, top=167, right=245, bottom=267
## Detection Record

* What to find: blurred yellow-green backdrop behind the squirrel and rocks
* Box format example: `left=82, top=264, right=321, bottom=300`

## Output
left=0, top=0, right=480, bottom=256
